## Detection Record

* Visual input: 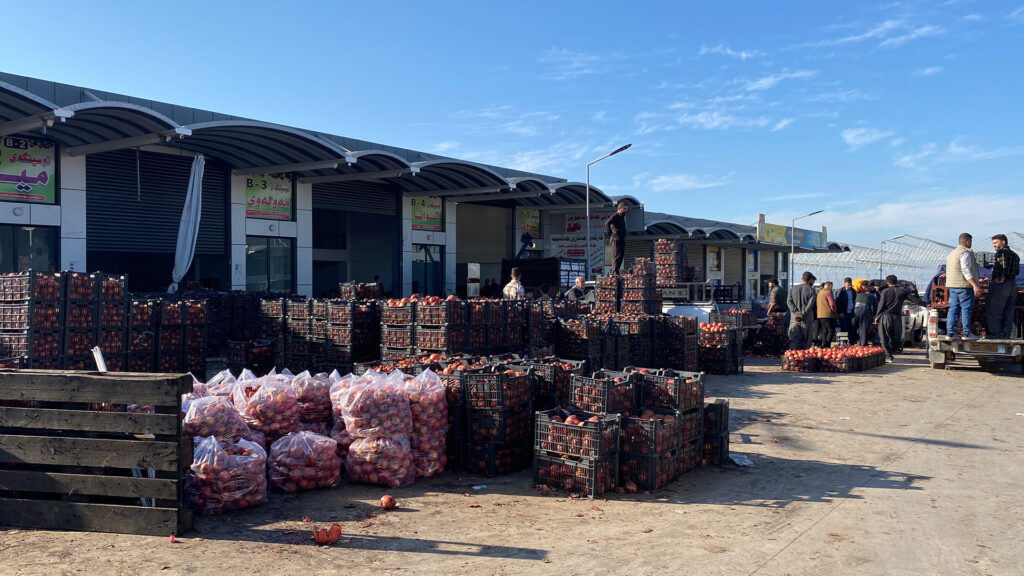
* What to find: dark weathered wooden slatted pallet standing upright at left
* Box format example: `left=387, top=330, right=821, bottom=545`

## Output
left=0, top=370, right=193, bottom=535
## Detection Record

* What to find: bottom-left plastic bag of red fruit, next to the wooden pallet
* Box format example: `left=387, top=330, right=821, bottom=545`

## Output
left=185, top=437, right=267, bottom=513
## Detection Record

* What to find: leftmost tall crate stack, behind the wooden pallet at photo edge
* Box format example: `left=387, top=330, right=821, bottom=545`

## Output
left=0, top=271, right=65, bottom=370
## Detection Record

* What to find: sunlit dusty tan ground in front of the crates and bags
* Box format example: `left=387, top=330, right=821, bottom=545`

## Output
left=0, top=349, right=1024, bottom=576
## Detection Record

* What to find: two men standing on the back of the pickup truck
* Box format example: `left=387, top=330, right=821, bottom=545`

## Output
left=945, top=232, right=1021, bottom=340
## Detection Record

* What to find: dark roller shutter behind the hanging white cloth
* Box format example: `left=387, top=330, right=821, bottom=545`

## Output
left=85, top=150, right=229, bottom=255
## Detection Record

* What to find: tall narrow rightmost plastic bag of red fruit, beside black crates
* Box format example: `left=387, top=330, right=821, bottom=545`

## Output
left=406, top=369, right=447, bottom=478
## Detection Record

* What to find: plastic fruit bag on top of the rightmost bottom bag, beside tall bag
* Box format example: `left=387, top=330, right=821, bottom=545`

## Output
left=340, top=372, right=413, bottom=438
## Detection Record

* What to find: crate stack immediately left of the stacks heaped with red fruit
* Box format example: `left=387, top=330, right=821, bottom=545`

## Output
left=324, top=300, right=381, bottom=373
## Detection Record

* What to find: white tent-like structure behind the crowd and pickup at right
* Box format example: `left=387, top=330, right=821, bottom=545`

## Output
left=793, top=233, right=950, bottom=292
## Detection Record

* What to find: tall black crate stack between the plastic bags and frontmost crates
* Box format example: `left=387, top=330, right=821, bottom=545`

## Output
left=462, top=364, right=534, bottom=477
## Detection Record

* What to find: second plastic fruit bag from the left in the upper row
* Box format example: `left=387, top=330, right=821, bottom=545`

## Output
left=231, top=375, right=299, bottom=442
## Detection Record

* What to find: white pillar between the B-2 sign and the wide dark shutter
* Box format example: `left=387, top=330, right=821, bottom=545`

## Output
left=58, top=151, right=89, bottom=272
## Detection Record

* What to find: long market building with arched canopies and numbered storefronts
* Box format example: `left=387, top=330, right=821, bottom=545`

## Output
left=0, top=73, right=839, bottom=297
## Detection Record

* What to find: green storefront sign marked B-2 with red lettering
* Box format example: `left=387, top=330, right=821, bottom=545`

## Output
left=0, top=136, right=57, bottom=204
